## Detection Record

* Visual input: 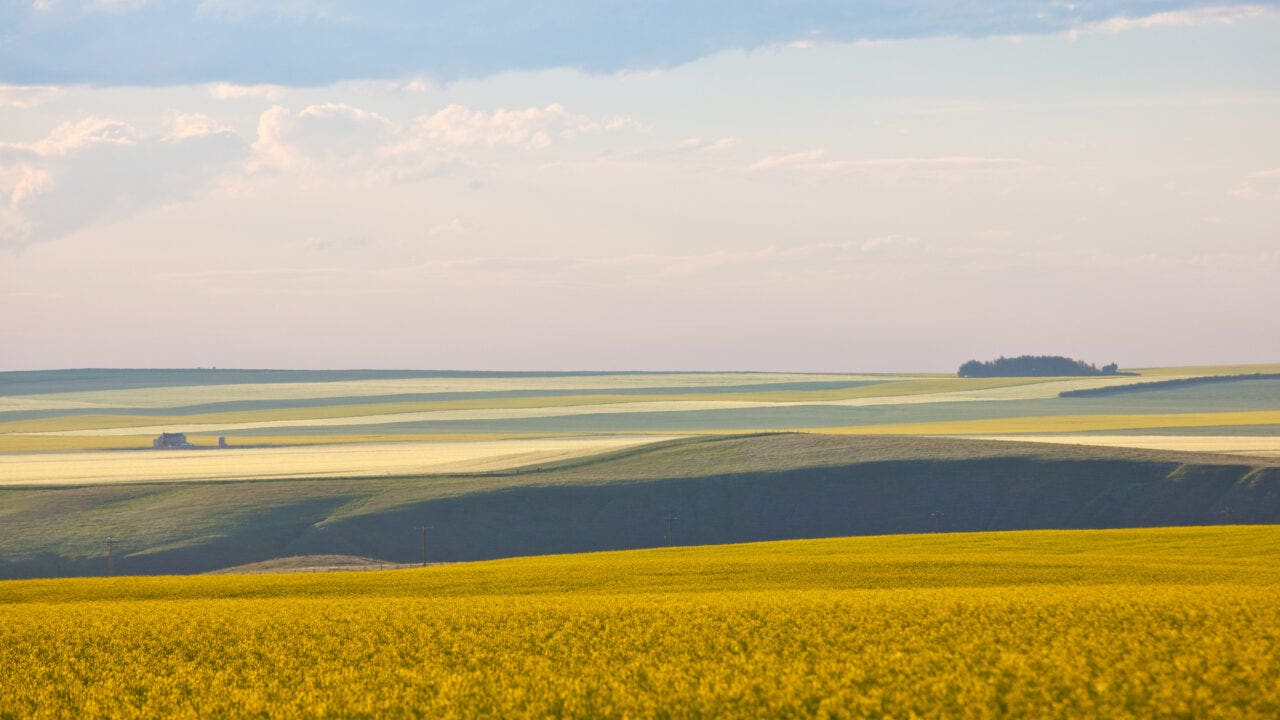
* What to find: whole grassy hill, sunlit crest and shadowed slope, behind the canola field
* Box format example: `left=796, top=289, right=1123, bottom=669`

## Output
left=0, top=434, right=1280, bottom=578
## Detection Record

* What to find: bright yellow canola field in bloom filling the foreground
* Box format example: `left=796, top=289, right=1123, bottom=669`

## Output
left=0, top=520, right=1280, bottom=720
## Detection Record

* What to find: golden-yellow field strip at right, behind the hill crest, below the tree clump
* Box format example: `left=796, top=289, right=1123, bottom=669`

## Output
left=797, top=410, right=1280, bottom=436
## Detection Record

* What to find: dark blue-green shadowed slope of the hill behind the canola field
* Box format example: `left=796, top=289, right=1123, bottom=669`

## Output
left=0, top=457, right=1280, bottom=578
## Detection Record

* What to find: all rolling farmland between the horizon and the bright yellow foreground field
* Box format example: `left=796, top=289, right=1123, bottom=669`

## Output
left=0, top=366, right=1280, bottom=577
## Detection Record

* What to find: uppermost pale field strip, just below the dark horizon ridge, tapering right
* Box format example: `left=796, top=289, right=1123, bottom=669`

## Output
left=0, top=373, right=911, bottom=411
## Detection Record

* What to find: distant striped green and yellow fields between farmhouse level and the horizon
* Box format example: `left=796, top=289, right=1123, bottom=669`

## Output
left=0, top=365, right=1280, bottom=456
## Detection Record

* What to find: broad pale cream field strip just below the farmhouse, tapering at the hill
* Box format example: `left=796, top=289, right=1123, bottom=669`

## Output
left=0, top=436, right=680, bottom=486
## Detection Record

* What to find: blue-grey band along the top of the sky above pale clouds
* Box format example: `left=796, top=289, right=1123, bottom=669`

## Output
left=0, top=0, right=1274, bottom=85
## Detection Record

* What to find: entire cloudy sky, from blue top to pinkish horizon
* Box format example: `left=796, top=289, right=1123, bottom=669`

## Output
left=0, top=0, right=1280, bottom=372
